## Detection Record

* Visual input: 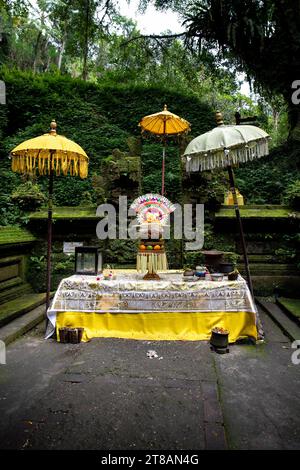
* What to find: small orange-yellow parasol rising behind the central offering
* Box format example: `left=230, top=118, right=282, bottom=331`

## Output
left=139, top=104, right=191, bottom=196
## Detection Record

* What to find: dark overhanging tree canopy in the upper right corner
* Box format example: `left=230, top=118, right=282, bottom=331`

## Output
left=142, top=0, right=300, bottom=139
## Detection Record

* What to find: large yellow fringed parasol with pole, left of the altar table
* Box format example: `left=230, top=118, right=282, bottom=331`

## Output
left=11, top=120, right=89, bottom=322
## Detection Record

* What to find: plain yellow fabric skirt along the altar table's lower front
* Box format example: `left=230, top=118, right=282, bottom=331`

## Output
left=56, top=312, right=257, bottom=343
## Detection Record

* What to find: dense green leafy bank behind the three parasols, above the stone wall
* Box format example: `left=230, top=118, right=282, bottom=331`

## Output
left=0, top=68, right=299, bottom=220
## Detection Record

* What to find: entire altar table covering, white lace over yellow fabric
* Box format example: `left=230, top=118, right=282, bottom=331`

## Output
left=47, top=270, right=257, bottom=342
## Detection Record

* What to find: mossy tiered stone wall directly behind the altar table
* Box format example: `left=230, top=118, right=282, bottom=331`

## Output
left=24, top=207, right=300, bottom=295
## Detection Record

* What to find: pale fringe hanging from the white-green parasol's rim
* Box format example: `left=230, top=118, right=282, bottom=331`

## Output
left=183, top=139, right=269, bottom=172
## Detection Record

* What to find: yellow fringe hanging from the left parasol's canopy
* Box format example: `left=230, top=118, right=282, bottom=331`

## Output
left=11, top=151, right=88, bottom=179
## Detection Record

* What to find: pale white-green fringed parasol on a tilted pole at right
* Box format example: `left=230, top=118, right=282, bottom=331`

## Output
left=183, top=112, right=270, bottom=295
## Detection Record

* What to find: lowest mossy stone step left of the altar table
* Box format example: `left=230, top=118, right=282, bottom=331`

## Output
left=0, top=293, right=46, bottom=327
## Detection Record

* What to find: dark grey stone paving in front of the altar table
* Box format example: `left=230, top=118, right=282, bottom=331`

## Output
left=0, top=313, right=300, bottom=450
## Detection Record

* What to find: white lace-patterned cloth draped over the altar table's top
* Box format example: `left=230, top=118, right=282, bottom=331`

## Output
left=47, top=270, right=257, bottom=337
